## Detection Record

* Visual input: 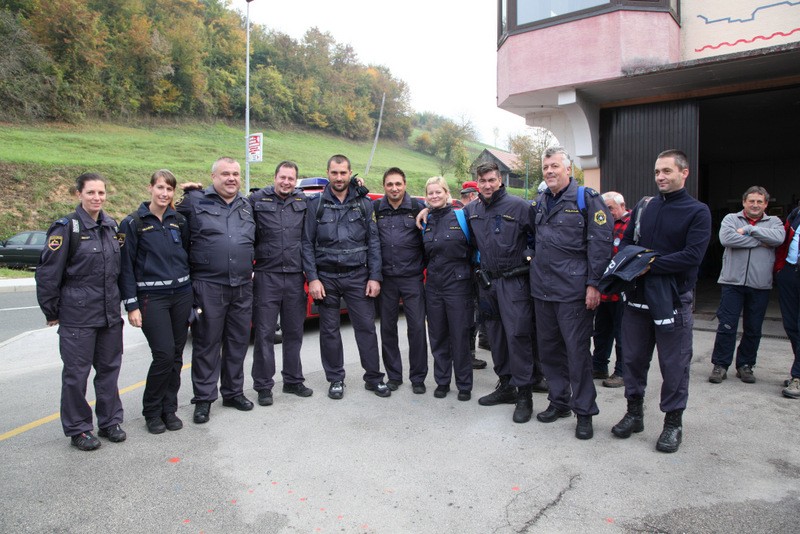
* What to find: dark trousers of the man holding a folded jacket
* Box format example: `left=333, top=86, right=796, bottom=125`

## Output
left=622, top=291, right=694, bottom=412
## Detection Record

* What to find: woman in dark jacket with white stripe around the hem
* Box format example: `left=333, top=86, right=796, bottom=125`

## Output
left=120, top=169, right=192, bottom=434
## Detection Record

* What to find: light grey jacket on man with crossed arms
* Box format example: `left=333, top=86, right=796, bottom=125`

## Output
left=717, top=211, right=786, bottom=289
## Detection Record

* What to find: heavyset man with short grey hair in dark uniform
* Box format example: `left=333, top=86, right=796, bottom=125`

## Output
left=177, top=158, right=256, bottom=424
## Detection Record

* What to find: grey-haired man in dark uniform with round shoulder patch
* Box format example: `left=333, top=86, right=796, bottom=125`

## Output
left=531, top=147, right=612, bottom=439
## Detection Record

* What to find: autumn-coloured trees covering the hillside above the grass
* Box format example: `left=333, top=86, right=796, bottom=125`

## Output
left=0, top=0, right=413, bottom=140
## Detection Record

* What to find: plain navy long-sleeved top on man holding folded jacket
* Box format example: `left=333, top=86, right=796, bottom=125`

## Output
left=619, top=188, right=711, bottom=295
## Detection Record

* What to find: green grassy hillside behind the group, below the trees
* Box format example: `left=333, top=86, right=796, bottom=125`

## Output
left=0, top=122, right=480, bottom=239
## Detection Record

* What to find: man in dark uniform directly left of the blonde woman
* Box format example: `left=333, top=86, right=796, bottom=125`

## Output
left=376, top=167, right=428, bottom=394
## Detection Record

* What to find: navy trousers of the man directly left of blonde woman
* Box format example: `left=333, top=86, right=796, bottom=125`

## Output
left=378, top=275, right=428, bottom=383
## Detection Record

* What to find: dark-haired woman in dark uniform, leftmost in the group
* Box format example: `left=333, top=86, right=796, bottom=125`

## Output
left=36, top=173, right=126, bottom=451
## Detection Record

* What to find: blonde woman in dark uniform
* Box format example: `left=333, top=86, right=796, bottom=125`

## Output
left=422, top=176, right=474, bottom=401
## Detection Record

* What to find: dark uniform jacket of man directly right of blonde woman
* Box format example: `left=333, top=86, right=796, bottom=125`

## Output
left=464, top=186, right=534, bottom=276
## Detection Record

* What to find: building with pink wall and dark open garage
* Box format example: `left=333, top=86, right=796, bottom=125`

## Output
left=497, top=0, right=800, bottom=229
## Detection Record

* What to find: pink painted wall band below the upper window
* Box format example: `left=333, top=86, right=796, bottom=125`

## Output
left=497, top=11, right=681, bottom=104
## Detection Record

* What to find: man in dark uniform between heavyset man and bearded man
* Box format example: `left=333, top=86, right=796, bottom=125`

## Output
left=249, top=161, right=314, bottom=406
